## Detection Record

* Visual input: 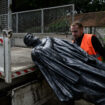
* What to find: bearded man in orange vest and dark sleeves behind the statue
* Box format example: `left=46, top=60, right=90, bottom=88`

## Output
left=70, top=22, right=105, bottom=61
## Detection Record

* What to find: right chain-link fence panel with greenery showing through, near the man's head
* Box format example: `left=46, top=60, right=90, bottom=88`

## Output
left=44, top=5, right=73, bottom=32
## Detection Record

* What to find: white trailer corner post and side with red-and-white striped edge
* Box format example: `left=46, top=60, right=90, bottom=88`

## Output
left=0, top=34, right=36, bottom=83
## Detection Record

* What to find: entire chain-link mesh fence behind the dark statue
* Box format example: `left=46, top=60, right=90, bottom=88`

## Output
left=0, top=4, right=74, bottom=33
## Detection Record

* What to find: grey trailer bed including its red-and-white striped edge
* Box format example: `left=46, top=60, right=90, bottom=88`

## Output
left=0, top=47, right=36, bottom=79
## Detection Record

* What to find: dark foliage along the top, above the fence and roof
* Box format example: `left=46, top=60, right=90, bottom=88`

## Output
left=12, top=0, right=105, bottom=13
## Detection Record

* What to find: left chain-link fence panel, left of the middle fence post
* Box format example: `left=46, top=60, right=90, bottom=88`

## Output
left=12, top=10, right=41, bottom=33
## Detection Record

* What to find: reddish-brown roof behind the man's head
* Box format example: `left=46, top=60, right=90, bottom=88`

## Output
left=74, top=11, right=105, bottom=27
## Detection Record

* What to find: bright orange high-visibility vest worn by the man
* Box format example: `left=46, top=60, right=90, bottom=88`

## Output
left=80, top=34, right=102, bottom=61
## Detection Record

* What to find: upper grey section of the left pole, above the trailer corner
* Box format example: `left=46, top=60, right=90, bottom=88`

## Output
left=8, top=0, right=12, bottom=29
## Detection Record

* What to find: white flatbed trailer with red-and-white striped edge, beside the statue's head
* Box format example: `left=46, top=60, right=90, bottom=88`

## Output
left=0, top=31, right=53, bottom=105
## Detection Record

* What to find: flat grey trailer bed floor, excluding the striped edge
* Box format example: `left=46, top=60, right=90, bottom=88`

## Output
left=11, top=47, right=34, bottom=72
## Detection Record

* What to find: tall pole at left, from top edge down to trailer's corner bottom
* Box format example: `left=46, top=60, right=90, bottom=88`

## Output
left=4, top=0, right=12, bottom=83
